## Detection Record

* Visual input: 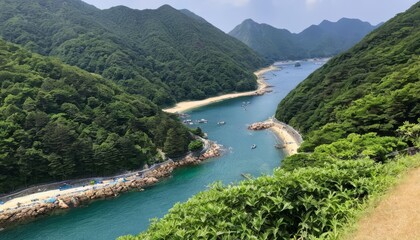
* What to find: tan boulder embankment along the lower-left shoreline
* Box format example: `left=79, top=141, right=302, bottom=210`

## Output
left=0, top=143, right=221, bottom=229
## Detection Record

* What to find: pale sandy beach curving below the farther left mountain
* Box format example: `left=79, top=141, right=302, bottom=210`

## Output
left=163, top=65, right=277, bottom=113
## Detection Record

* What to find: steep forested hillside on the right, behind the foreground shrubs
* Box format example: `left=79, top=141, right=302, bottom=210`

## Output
left=276, top=3, right=420, bottom=151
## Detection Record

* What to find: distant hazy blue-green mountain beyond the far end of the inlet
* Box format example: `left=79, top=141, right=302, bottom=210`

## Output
left=229, top=18, right=375, bottom=61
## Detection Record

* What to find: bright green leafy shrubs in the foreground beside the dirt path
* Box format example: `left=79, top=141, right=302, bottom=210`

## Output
left=120, top=155, right=420, bottom=240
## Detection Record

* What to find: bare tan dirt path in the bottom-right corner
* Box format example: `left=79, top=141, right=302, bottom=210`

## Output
left=349, top=168, right=420, bottom=240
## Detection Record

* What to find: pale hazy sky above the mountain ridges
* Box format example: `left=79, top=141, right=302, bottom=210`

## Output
left=83, top=0, right=417, bottom=32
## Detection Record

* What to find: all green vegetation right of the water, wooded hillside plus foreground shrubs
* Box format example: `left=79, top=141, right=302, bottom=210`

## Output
left=121, top=3, right=420, bottom=239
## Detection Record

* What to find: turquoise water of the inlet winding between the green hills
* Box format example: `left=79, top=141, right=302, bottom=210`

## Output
left=0, top=62, right=320, bottom=240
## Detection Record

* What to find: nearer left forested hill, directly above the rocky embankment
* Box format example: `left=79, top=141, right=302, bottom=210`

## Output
left=0, top=40, right=190, bottom=193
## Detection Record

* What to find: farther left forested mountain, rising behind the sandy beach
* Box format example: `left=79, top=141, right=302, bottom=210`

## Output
left=0, top=0, right=264, bottom=106
